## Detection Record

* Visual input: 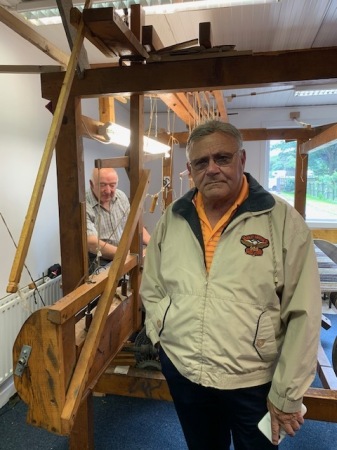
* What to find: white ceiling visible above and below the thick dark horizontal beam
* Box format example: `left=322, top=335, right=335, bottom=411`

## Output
left=0, top=0, right=337, bottom=112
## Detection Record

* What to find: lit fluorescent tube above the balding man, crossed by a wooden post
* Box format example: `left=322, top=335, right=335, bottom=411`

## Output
left=98, top=122, right=171, bottom=155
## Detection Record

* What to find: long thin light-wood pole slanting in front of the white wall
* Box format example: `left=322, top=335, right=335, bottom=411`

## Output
left=7, top=0, right=92, bottom=292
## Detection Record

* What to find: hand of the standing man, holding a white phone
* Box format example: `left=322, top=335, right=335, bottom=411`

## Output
left=268, top=400, right=304, bottom=445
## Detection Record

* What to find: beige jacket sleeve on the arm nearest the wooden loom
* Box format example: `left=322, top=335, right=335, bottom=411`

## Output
left=140, top=220, right=166, bottom=345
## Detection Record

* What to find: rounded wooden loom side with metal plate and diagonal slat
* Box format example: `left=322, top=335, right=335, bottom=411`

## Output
left=13, top=172, right=149, bottom=448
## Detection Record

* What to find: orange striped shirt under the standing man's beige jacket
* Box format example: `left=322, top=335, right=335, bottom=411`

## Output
left=194, top=175, right=249, bottom=272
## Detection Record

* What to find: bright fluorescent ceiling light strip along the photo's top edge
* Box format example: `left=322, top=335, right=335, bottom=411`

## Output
left=16, top=0, right=281, bottom=26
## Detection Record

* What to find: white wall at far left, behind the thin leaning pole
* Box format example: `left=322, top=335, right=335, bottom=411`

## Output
left=0, top=23, right=60, bottom=298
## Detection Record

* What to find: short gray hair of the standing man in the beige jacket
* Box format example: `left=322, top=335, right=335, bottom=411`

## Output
left=186, top=120, right=243, bottom=161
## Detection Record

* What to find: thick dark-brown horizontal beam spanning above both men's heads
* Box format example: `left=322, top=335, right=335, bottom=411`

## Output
left=41, top=47, right=337, bottom=99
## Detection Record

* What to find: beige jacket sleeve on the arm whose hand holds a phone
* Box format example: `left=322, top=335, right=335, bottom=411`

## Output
left=269, top=216, right=322, bottom=413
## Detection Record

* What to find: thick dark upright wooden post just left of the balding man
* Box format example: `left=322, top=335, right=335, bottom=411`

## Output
left=55, top=98, right=88, bottom=295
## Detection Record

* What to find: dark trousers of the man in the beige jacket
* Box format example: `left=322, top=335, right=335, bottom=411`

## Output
left=159, top=349, right=278, bottom=450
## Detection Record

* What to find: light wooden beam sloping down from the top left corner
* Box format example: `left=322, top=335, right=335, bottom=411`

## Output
left=0, top=6, right=69, bottom=67
